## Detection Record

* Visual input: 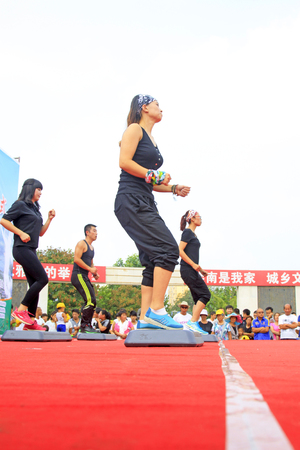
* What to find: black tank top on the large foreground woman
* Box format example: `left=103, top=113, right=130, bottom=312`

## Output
left=118, top=128, right=164, bottom=198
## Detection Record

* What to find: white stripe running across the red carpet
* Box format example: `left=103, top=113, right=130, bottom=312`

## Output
left=219, top=341, right=293, bottom=450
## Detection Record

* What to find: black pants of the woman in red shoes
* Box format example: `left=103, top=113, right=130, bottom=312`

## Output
left=13, top=245, right=48, bottom=317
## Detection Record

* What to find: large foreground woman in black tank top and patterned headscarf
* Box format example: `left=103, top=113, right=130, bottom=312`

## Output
left=115, top=95, right=190, bottom=329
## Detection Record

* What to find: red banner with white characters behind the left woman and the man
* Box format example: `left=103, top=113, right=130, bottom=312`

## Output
left=13, top=261, right=106, bottom=283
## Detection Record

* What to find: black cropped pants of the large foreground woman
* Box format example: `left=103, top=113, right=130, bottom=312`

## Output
left=115, top=194, right=179, bottom=286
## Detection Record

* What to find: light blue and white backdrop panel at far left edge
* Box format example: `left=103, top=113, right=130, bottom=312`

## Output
left=0, top=150, right=19, bottom=300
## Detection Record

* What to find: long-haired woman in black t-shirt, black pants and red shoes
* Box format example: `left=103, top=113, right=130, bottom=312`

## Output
left=0, top=178, right=55, bottom=331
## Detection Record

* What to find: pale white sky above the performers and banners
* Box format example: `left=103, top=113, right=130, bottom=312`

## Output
left=0, top=0, right=300, bottom=270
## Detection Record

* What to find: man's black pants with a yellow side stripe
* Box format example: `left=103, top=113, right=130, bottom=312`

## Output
left=71, top=272, right=97, bottom=327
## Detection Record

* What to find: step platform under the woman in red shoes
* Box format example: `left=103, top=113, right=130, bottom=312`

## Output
left=1, top=330, right=72, bottom=342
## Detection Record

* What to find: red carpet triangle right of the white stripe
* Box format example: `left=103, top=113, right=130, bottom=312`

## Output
left=225, top=341, right=300, bottom=449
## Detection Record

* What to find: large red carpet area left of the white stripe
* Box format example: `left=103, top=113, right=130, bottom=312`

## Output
left=0, top=340, right=225, bottom=450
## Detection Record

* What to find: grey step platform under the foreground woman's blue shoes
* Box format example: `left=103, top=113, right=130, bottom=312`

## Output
left=125, top=329, right=203, bottom=347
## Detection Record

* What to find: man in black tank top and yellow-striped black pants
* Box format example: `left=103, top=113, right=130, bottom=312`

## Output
left=71, top=223, right=99, bottom=333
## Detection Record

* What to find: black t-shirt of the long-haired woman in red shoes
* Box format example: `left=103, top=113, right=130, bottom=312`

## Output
left=2, top=200, right=43, bottom=248
